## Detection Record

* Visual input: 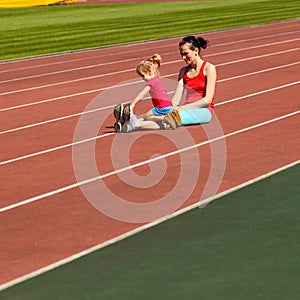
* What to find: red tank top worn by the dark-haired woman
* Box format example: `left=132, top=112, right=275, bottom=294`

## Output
left=183, top=61, right=214, bottom=110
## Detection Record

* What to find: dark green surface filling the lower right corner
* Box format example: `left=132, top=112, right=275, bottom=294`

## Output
left=0, top=165, right=300, bottom=300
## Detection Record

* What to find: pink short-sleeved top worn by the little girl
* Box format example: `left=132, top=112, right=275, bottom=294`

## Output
left=146, top=76, right=172, bottom=108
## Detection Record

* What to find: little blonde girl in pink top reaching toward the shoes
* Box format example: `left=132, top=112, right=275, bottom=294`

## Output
left=114, top=54, right=173, bottom=132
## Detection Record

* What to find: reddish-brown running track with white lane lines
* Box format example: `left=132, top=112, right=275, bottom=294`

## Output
left=0, top=20, right=300, bottom=288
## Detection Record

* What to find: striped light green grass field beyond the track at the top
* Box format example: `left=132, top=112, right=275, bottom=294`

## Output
left=0, top=0, right=300, bottom=60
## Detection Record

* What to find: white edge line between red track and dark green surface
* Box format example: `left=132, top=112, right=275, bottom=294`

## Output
left=0, top=160, right=300, bottom=291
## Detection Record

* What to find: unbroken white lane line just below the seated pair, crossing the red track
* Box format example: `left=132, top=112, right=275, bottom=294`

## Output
left=0, top=110, right=300, bottom=213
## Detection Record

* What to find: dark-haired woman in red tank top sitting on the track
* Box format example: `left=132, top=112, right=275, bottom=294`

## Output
left=113, top=36, right=217, bottom=132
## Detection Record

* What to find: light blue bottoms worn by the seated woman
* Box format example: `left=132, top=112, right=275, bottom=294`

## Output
left=179, top=108, right=211, bottom=126
